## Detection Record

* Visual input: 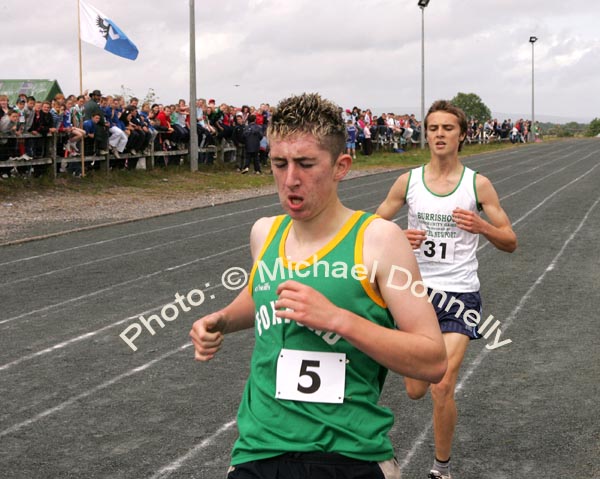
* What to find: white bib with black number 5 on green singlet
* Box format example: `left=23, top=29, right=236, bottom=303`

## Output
left=275, top=349, right=346, bottom=403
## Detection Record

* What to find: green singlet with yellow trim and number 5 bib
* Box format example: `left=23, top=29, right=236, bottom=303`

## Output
left=232, top=211, right=394, bottom=465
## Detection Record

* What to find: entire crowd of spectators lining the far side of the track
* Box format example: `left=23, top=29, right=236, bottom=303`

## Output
left=8, top=90, right=544, bottom=180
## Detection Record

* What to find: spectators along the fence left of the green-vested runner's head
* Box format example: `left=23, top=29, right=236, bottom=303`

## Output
left=0, top=90, right=278, bottom=174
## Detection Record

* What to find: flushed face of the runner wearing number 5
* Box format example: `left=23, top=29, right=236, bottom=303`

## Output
left=270, top=135, right=346, bottom=220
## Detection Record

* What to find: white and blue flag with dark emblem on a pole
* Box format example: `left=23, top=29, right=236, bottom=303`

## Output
left=79, top=0, right=139, bottom=60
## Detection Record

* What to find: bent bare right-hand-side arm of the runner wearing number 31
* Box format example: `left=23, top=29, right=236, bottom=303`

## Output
left=453, top=175, right=517, bottom=253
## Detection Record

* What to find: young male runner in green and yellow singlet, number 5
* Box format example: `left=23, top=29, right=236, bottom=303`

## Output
left=190, top=94, right=446, bottom=479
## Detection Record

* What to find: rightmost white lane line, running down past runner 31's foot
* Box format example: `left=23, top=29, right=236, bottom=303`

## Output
left=400, top=198, right=600, bottom=469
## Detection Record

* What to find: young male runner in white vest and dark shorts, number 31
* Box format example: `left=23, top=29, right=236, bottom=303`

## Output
left=377, top=100, right=517, bottom=479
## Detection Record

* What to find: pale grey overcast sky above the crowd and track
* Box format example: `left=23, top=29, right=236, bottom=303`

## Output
left=0, top=0, right=600, bottom=122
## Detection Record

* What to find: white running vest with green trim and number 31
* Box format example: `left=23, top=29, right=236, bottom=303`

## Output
left=406, top=166, right=479, bottom=293
